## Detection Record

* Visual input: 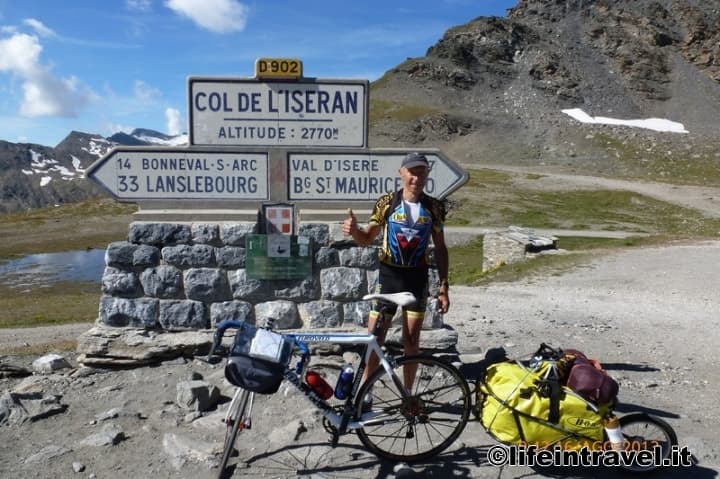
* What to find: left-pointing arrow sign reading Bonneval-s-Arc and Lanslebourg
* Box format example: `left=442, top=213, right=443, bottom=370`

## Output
left=87, top=147, right=269, bottom=200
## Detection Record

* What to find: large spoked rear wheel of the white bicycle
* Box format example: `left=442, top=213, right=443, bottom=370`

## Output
left=356, top=356, right=471, bottom=462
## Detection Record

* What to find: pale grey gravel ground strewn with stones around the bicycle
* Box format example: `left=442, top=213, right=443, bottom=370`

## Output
left=0, top=241, right=720, bottom=479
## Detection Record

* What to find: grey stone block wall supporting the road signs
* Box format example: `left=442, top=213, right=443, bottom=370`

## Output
left=97, top=222, right=442, bottom=331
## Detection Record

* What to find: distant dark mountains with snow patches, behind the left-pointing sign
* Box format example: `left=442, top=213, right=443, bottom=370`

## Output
left=0, top=129, right=187, bottom=213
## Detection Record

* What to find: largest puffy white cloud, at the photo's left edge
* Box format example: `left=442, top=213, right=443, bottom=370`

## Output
left=0, top=33, right=97, bottom=117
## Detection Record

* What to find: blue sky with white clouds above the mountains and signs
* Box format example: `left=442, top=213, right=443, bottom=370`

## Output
left=0, top=0, right=517, bottom=146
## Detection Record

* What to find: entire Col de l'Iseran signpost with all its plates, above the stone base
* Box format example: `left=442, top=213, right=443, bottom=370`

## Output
left=87, top=58, right=468, bottom=221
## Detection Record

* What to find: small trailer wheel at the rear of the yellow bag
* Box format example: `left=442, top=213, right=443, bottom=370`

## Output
left=620, top=413, right=677, bottom=474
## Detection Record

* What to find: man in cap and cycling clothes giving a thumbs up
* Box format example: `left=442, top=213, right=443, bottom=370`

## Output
left=342, top=153, right=450, bottom=388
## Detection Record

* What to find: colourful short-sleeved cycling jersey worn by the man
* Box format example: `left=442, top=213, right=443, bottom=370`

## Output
left=370, top=190, right=445, bottom=267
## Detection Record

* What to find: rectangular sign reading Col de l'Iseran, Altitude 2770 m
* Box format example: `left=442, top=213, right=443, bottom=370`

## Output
left=188, top=77, right=369, bottom=148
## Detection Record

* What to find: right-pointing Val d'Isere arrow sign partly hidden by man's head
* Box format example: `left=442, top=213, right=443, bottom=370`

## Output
left=288, top=150, right=468, bottom=201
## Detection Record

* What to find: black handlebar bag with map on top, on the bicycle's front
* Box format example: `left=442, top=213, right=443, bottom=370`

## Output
left=225, top=324, right=292, bottom=394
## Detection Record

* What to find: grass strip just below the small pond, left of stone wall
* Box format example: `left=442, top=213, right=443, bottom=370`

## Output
left=0, top=281, right=101, bottom=328
